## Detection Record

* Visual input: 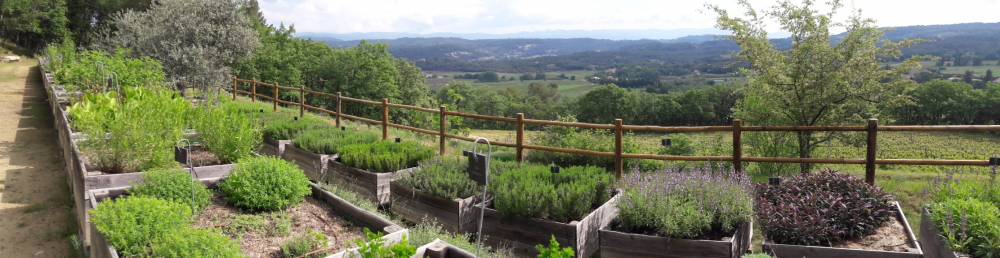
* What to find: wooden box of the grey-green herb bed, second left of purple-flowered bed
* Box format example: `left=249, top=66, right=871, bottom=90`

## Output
left=389, top=174, right=480, bottom=233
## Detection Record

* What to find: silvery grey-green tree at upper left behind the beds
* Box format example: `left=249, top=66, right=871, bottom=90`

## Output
left=101, top=0, right=259, bottom=93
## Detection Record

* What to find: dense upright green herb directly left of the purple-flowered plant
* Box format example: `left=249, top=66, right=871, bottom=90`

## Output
left=489, top=165, right=614, bottom=222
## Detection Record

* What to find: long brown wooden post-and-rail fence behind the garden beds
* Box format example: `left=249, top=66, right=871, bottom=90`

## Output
left=231, top=77, right=1000, bottom=184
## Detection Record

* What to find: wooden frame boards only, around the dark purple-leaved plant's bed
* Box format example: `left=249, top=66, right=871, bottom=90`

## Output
left=764, top=202, right=924, bottom=258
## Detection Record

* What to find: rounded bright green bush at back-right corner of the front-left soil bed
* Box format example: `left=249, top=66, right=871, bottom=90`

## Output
left=219, top=157, right=312, bottom=211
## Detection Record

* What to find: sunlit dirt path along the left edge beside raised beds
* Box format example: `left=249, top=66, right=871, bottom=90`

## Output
left=0, top=60, right=76, bottom=257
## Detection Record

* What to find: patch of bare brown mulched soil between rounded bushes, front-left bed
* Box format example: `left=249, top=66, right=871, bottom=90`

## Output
left=195, top=194, right=363, bottom=257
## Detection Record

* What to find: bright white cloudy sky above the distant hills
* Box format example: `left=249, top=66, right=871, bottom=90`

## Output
left=259, top=0, right=1000, bottom=38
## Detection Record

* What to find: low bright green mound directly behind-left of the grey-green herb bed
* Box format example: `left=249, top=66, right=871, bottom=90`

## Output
left=339, top=141, right=434, bottom=173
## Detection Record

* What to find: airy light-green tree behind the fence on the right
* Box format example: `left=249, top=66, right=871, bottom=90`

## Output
left=711, top=0, right=917, bottom=172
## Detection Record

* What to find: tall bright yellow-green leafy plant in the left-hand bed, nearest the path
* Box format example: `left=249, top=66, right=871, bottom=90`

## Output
left=70, top=88, right=191, bottom=173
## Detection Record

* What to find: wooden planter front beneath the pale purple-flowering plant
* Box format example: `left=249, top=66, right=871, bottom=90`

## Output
left=599, top=221, right=753, bottom=258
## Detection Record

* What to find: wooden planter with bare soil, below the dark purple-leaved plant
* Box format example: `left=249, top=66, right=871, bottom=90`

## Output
left=764, top=202, right=924, bottom=258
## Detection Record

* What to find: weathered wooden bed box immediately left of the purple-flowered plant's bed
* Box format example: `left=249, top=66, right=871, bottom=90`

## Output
left=469, top=188, right=621, bottom=257
